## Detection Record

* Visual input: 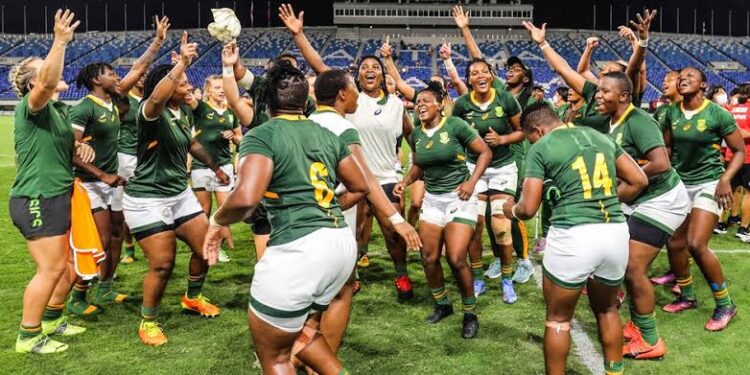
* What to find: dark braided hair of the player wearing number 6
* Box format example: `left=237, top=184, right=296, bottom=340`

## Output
left=266, top=60, right=309, bottom=113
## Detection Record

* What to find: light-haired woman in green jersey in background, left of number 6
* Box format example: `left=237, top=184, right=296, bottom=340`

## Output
left=188, top=75, right=242, bottom=262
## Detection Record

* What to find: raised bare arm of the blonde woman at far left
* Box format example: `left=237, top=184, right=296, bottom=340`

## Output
left=29, top=9, right=81, bottom=113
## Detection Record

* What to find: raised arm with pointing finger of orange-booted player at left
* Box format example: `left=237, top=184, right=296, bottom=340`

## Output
left=143, top=31, right=198, bottom=119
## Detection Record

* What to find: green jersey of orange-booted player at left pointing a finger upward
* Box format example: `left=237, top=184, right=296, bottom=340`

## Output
left=125, top=105, right=193, bottom=198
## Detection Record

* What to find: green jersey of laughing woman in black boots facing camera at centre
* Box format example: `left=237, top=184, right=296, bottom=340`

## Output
left=409, top=116, right=479, bottom=194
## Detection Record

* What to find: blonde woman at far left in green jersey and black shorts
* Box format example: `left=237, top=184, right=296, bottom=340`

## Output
left=8, top=10, right=94, bottom=354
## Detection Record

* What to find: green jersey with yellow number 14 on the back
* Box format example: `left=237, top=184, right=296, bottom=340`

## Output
left=525, top=124, right=625, bottom=228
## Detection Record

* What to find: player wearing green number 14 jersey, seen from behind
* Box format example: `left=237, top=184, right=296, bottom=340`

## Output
left=503, top=103, right=648, bottom=375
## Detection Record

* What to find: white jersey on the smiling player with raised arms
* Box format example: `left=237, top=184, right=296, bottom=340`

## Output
left=346, top=93, right=404, bottom=185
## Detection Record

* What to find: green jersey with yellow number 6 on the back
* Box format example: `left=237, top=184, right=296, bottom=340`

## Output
left=240, top=115, right=350, bottom=246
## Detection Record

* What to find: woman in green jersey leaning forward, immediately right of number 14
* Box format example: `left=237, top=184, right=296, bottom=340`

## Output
left=596, top=72, right=690, bottom=359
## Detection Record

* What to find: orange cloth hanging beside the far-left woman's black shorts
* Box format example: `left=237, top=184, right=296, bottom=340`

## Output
left=70, top=179, right=106, bottom=279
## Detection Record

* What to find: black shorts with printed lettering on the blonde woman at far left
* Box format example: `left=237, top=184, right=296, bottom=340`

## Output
left=8, top=193, right=70, bottom=239
